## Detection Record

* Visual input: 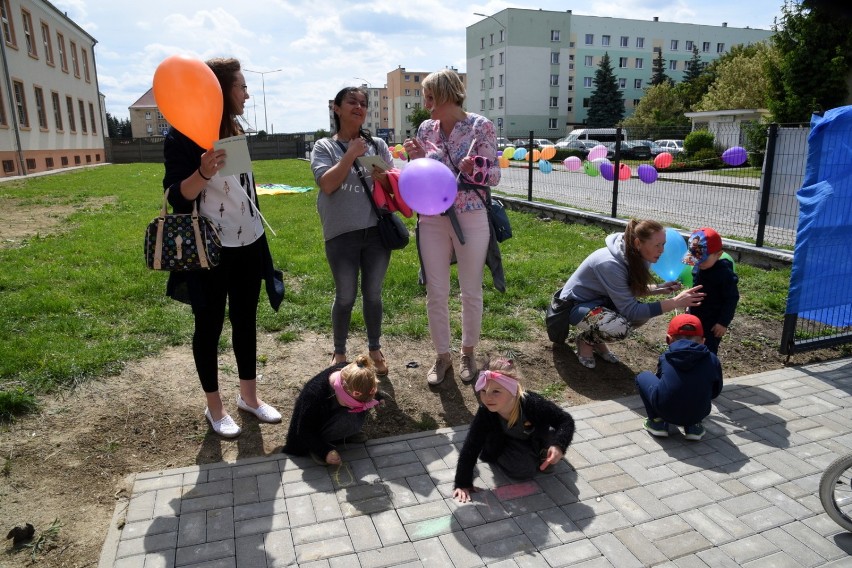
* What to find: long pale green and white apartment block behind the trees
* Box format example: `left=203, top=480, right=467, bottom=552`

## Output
left=467, top=8, right=772, bottom=138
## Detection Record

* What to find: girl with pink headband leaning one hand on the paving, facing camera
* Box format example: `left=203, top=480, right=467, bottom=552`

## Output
left=453, top=358, right=574, bottom=503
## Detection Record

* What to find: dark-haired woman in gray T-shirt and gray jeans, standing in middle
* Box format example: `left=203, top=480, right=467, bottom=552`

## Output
left=311, top=87, right=393, bottom=375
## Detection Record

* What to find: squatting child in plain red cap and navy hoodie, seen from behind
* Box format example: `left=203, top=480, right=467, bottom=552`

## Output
left=636, top=314, right=722, bottom=440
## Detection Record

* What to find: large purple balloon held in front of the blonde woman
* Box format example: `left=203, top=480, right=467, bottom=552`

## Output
left=399, top=158, right=458, bottom=215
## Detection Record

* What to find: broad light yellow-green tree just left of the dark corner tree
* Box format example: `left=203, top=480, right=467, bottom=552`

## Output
left=693, top=42, right=777, bottom=111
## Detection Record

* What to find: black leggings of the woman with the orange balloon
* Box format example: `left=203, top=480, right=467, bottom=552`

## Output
left=192, top=237, right=264, bottom=393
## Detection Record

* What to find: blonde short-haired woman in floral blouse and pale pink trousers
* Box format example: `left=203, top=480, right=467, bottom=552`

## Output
left=404, top=69, right=500, bottom=386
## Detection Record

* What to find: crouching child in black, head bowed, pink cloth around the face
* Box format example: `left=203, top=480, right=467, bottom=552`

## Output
left=281, top=354, right=382, bottom=465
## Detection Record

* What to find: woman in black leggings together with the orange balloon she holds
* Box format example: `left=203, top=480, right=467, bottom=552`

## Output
left=154, top=58, right=284, bottom=438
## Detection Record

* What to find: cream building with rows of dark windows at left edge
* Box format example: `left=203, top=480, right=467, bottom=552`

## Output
left=0, top=0, right=106, bottom=176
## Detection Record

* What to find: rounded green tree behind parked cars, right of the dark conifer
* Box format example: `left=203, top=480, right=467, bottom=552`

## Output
left=622, top=82, right=689, bottom=140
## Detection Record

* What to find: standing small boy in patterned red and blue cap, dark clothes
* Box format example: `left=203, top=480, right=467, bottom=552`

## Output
left=683, top=227, right=740, bottom=353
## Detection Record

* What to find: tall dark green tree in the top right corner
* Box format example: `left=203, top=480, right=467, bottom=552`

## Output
left=769, top=0, right=852, bottom=122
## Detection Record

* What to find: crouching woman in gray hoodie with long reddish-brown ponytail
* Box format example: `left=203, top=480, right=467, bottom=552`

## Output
left=547, top=219, right=704, bottom=369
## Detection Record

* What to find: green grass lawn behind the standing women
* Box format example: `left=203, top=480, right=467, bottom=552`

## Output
left=0, top=160, right=790, bottom=421
